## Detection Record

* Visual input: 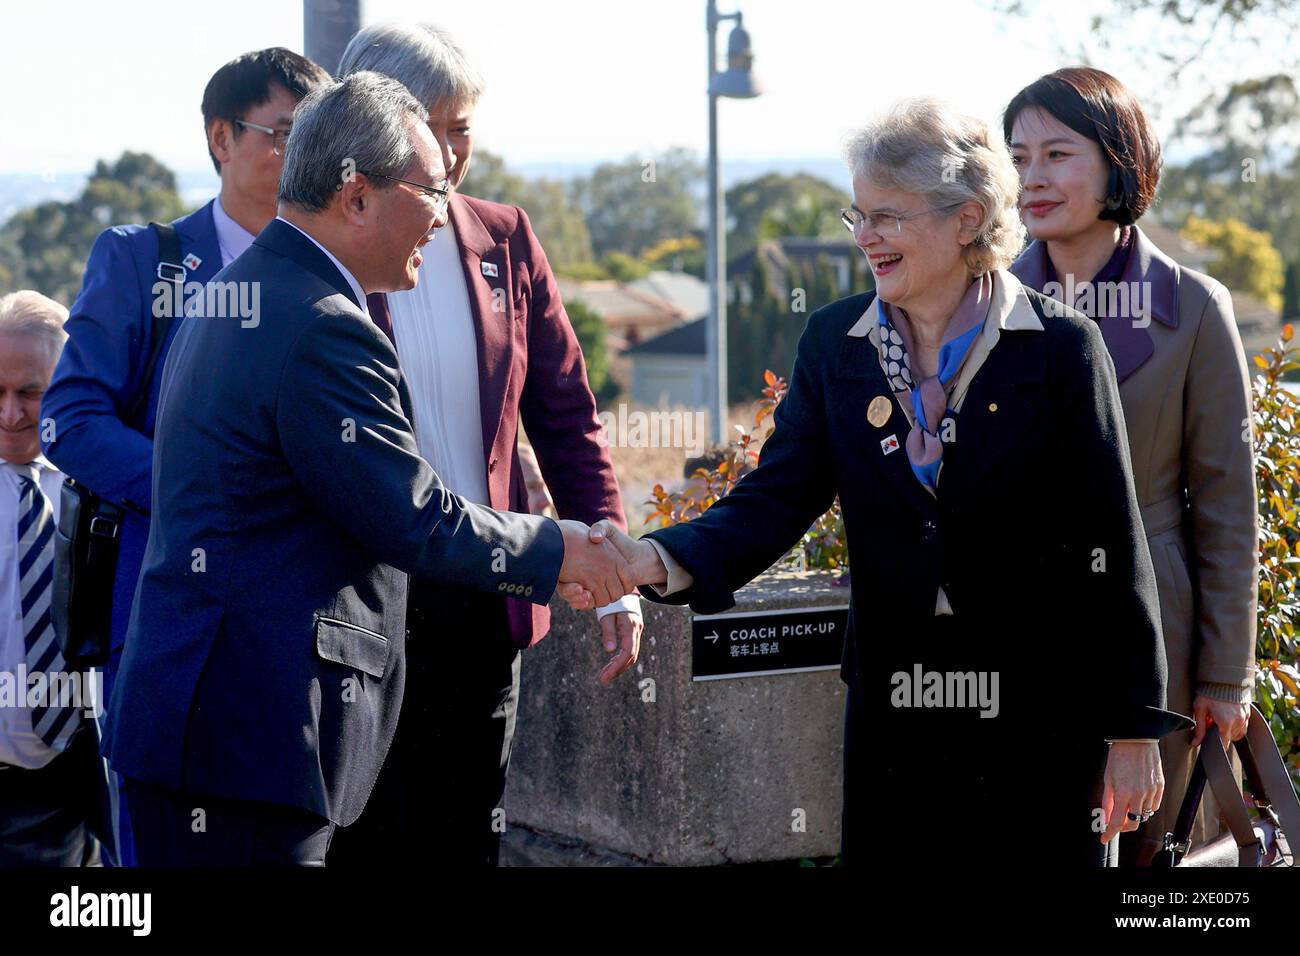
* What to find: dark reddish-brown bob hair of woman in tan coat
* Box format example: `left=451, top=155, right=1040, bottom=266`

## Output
left=1002, top=66, right=1161, bottom=225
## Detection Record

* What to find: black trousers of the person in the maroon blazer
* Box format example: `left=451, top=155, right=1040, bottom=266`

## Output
left=329, top=581, right=519, bottom=869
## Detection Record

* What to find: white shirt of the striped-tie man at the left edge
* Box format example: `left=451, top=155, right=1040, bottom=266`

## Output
left=0, top=455, right=66, bottom=770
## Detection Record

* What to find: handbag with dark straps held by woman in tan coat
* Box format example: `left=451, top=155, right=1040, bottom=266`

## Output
left=1151, top=705, right=1300, bottom=869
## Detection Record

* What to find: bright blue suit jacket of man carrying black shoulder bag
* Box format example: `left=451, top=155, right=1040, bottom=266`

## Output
left=40, top=202, right=221, bottom=676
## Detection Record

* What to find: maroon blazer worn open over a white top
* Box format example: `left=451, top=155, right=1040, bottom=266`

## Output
left=369, top=193, right=627, bottom=648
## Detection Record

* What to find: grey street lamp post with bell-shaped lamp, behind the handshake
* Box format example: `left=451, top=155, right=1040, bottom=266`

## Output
left=707, top=0, right=762, bottom=444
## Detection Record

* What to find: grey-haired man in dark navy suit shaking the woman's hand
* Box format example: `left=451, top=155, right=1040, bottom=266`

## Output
left=98, top=72, right=632, bottom=866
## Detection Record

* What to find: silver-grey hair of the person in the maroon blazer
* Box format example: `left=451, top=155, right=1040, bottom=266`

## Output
left=338, top=23, right=484, bottom=109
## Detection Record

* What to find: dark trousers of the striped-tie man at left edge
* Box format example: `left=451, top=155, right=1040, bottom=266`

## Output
left=0, top=718, right=100, bottom=866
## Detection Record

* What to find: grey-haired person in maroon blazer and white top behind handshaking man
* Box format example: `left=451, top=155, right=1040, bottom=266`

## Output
left=329, top=25, right=641, bottom=866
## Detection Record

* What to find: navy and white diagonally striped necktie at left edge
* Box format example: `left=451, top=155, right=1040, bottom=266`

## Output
left=18, top=466, right=81, bottom=749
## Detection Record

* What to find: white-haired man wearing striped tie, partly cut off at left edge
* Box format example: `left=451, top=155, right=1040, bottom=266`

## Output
left=0, top=291, right=99, bottom=866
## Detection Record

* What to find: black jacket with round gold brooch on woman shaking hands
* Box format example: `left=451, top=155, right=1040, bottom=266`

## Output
left=641, top=276, right=1191, bottom=743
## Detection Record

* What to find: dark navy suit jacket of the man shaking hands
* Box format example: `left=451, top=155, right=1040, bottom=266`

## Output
left=105, top=220, right=564, bottom=826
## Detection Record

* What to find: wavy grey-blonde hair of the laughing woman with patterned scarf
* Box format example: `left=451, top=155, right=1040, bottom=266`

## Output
left=845, top=98, right=1024, bottom=274
